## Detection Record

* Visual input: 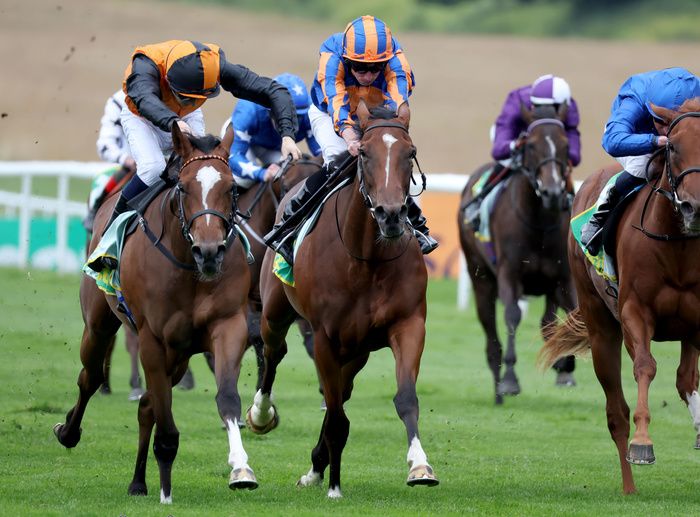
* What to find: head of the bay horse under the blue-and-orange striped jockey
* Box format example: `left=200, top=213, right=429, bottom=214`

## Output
left=356, top=102, right=416, bottom=239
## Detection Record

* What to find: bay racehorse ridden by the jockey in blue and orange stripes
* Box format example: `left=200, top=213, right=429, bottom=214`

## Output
left=246, top=102, right=438, bottom=498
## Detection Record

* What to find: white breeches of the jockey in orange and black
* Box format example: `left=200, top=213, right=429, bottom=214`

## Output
left=121, top=108, right=204, bottom=186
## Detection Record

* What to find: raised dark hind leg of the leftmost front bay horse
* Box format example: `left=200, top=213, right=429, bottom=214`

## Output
left=54, top=279, right=120, bottom=448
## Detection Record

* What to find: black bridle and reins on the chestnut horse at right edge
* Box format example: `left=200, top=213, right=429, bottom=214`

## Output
left=632, top=111, right=700, bottom=242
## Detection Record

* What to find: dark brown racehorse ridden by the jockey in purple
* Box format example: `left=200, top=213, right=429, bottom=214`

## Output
left=457, top=104, right=576, bottom=404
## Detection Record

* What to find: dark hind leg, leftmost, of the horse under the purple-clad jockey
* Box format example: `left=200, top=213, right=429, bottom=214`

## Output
left=469, top=263, right=503, bottom=404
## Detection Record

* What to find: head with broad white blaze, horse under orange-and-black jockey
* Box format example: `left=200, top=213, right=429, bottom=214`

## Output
left=172, top=124, right=236, bottom=280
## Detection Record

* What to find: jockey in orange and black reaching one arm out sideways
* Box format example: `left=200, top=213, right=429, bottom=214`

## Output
left=90, top=40, right=301, bottom=267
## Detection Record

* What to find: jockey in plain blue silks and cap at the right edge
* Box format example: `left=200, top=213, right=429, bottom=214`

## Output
left=581, top=68, right=700, bottom=255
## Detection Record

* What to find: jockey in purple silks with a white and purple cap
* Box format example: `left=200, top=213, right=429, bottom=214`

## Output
left=465, top=74, right=581, bottom=225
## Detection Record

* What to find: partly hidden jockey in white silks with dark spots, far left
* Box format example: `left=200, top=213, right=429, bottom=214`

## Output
left=83, top=90, right=136, bottom=232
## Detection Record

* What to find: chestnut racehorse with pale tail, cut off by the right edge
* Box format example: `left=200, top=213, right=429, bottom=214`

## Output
left=540, top=98, right=700, bottom=494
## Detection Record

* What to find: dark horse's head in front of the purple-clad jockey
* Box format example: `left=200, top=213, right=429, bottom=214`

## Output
left=520, top=103, right=569, bottom=210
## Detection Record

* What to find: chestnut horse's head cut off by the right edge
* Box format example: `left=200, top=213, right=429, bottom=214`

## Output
left=651, top=97, right=700, bottom=233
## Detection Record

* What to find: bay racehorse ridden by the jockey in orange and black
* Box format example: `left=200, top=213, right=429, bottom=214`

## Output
left=54, top=124, right=257, bottom=503
